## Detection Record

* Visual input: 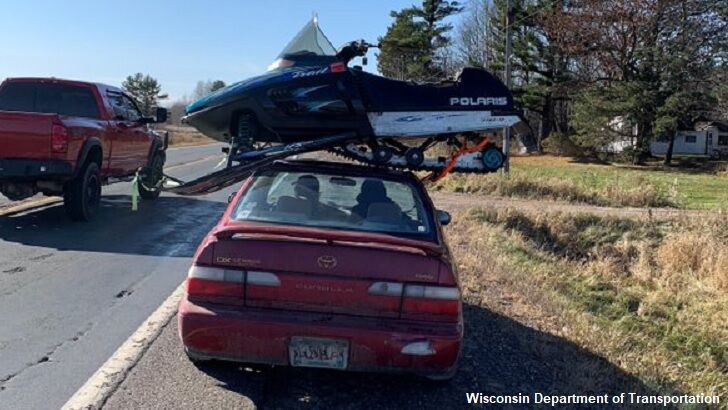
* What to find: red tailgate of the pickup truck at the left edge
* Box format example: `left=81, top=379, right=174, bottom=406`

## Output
left=0, top=111, right=57, bottom=159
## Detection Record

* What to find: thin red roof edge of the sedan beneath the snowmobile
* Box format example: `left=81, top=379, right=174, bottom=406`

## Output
left=256, top=159, right=418, bottom=181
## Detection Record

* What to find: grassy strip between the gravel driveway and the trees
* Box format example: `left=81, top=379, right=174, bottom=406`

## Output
left=435, top=156, right=728, bottom=209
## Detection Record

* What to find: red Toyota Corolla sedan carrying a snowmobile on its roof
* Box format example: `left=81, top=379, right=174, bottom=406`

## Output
left=178, top=161, right=463, bottom=379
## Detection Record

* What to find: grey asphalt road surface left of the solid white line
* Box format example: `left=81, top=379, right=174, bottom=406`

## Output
left=0, top=145, right=230, bottom=409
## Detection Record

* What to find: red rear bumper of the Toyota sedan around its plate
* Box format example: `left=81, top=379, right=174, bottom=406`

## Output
left=178, top=298, right=463, bottom=376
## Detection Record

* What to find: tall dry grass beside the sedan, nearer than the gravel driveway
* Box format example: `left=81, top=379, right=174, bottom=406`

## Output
left=448, top=210, right=728, bottom=398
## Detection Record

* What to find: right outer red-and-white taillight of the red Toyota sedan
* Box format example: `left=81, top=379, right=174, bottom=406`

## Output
left=402, top=285, right=460, bottom=321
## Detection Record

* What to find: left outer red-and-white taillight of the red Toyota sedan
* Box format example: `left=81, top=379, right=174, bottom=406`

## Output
left=187, top=265, right=245, bottom=298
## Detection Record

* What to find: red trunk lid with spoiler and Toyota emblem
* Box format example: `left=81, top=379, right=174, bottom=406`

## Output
left=208, top=227, right=440, bottom=317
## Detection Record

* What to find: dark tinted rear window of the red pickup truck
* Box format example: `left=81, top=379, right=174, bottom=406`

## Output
left=0, top=82, right=100, bottom=118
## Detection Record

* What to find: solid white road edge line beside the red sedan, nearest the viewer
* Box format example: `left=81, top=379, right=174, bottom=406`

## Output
left=62, top=282, right=184, bottom=410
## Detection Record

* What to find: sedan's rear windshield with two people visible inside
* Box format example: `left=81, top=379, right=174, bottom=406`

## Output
left=233, top=171, right=434, bottom=240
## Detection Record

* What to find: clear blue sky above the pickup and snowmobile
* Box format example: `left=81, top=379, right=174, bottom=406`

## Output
left=0, top=0, right=438, bottom=99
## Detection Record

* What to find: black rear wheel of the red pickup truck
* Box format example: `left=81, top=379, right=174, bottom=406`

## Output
left=63, top=162, right=101, bottom=221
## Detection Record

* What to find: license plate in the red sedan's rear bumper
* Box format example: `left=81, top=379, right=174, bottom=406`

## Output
left=288, top=337, right=349, bottom=369
